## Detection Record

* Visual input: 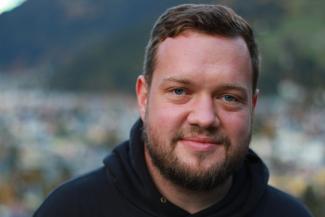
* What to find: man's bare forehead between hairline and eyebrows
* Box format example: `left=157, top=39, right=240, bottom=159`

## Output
left=153, top=31, right=252, bottom=88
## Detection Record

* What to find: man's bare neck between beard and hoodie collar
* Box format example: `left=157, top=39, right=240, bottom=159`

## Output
left=145, top=147, right=232, bottom=214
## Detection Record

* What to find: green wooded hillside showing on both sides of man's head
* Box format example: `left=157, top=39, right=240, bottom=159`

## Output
left=46, top=0, right=325, bottom=94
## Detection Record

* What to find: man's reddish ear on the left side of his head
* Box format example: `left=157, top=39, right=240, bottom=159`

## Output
left=136, top=75, right=148, bottom=120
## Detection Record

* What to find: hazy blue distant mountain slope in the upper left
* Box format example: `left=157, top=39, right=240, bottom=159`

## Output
left=0, top=0, right=202, bottom=69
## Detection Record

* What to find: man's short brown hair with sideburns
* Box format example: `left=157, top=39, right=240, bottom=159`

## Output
left=144, top=4, right=259, bottom=91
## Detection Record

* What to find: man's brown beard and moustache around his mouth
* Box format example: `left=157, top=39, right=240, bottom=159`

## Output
left=143, top=118, right=251, bottom=191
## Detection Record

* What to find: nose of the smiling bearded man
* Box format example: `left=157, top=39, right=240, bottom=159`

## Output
left=187, top=96, right=219, bottom=128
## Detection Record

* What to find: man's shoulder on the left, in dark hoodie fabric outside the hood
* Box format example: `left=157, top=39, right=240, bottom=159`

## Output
left=34, top=167, right=112, bottom=217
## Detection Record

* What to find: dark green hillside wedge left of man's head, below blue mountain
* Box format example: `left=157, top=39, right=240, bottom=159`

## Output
left=51, top=28, right=145, bottom=92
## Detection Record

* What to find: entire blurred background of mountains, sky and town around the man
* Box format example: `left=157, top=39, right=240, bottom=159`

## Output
left=0, top=0, right=325, bottom=217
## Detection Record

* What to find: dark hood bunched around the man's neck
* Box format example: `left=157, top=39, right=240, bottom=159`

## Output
left=104, top=120, right=269, bottom=217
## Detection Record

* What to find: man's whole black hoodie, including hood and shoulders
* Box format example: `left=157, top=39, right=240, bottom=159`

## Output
left=34, top=121, right=311, bottom=217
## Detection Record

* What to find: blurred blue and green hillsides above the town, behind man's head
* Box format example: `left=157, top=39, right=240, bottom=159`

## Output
left=0, top=0, right=325, bottom=93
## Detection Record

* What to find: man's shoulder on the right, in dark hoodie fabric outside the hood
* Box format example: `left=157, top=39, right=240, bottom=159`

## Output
left=256, top=186, right=312, bottom=217
